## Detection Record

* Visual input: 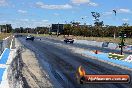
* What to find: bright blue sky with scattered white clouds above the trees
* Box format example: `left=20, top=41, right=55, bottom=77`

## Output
left=0, top=0, right=132, bottom=28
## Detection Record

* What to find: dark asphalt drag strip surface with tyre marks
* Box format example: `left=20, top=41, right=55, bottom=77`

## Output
left=18, top=37, right=132, bottom=88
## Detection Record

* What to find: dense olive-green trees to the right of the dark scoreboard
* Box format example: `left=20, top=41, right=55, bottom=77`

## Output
left=63, top=24, right=132, bottom=37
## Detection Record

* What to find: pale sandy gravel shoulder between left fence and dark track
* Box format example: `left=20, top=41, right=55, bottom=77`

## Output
left=16, top=38, right=53, bottom=88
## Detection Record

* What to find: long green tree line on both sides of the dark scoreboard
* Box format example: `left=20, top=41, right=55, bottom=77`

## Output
left=14, top=22, right=132, bottom=37
